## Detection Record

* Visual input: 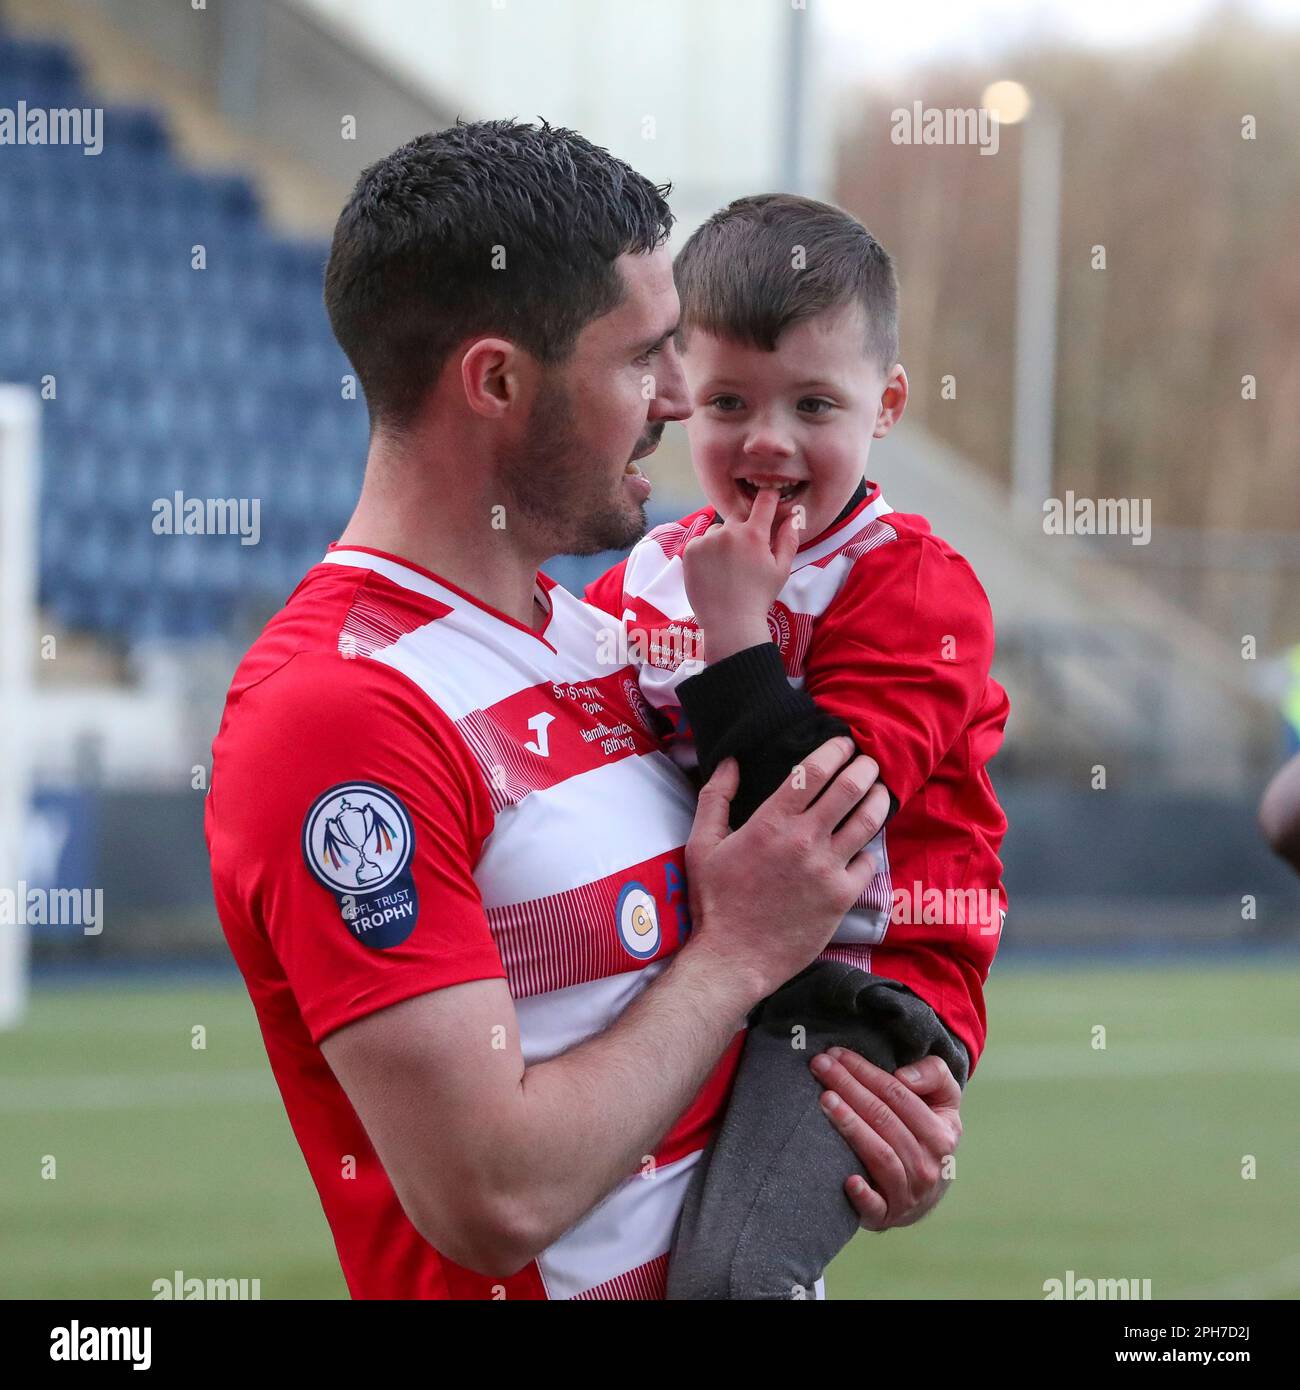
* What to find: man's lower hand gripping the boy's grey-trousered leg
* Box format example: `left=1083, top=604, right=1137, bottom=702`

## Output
left=809, top=1047, right=962, bottom=1230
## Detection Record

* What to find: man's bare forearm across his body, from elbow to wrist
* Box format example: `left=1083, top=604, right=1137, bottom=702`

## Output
left=502, top=944, right=763, bottom=1258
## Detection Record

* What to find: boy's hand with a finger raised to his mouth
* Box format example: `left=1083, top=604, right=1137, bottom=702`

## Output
left=681, top=488, right=799, bottom=663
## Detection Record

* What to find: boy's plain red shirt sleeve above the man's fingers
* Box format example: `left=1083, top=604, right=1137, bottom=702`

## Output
left=805, top=538, right=994, bottom=805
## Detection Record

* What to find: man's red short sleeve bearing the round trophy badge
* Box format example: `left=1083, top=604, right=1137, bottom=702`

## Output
left=207, top=653, right=505, bottom=1043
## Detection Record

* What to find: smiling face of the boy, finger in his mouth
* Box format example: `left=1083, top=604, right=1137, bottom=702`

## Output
left=681, top=304, right=908, bottom=545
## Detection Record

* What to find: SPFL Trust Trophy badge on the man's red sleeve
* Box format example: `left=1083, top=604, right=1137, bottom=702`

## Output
left=303, top=781, right=420, bottom=951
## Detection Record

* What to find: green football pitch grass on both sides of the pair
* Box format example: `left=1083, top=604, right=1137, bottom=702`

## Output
left=0, top=955, right=1300, bottom=1300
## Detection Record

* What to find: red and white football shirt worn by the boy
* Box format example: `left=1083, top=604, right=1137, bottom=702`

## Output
left=587, top=482, right=1009, bottom=1070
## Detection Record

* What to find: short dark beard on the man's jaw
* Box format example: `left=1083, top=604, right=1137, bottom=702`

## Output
left=501, top=374, right=663, bottom=555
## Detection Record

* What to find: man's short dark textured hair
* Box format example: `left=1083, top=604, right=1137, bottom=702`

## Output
left=325, top=121, right=673, bottom=428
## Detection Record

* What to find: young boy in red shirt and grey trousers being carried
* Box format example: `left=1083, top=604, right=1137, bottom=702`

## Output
left=587, top=195, right=1008, bottom=1298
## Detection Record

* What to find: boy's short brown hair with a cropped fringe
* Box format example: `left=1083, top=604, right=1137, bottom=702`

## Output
left=673, top=193, right=898, bottom=370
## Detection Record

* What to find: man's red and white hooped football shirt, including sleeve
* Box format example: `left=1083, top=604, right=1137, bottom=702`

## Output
left=206, top=546, right=742, bottom=1298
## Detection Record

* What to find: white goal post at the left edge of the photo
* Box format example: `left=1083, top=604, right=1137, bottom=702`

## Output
left=0, top=384, right=40, bottom=1029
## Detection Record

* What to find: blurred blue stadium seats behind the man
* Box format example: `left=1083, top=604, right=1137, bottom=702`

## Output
left=0, top=29, right=658, bottom=641
